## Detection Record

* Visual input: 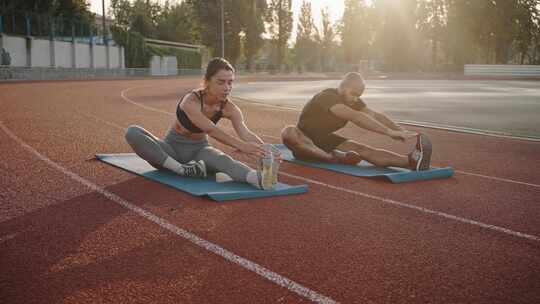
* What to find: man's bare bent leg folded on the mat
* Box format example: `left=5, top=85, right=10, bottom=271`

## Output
left=281, top=126, right=362, bottom=164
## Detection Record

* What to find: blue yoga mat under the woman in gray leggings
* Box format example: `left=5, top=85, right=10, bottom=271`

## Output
left=96, top=153, right=308, bottom=202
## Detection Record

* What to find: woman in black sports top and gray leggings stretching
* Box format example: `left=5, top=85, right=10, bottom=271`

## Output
left=126, top=58, right=277, bottom=190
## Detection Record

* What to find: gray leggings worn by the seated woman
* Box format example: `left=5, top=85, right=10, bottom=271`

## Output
left=126, top=125, right=251, bottom=182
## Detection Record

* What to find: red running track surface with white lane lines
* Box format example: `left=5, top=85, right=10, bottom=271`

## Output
left=0, top=79, right=540, bottom=303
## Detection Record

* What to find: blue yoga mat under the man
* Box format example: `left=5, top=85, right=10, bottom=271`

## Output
left=275, top=145, right=454, bottom=183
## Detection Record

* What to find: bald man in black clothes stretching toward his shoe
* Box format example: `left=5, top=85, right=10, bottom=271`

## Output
left=281, top=72, right=432, bottom=170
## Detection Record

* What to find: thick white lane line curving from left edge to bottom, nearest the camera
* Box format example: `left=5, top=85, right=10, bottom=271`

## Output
left=0, top=121, right=337, bottom=303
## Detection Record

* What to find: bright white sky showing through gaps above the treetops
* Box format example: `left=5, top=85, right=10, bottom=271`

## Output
left=87, top=0, right=343, bottom=27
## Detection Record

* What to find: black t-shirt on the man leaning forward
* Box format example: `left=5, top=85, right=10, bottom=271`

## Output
left=298, top=89, right=366, bottom=135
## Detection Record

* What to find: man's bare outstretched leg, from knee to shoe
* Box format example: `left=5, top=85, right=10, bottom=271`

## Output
left=336, top=140, right=409, bottom=168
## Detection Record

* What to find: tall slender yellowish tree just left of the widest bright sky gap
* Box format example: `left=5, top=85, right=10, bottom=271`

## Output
left=267, top=0, right=293, bottom=70
